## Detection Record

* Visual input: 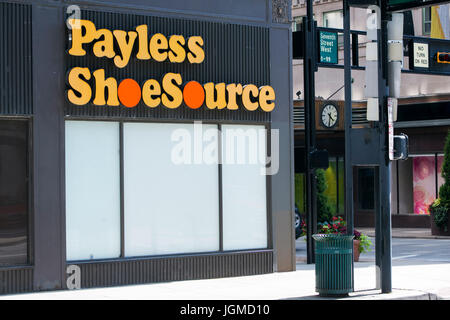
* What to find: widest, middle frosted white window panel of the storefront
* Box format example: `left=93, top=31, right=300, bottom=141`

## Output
left=124, top=123, right=219, bottom=257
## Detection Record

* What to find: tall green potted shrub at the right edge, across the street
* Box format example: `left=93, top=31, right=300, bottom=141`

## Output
left=429, top=131, right=450, bottom=236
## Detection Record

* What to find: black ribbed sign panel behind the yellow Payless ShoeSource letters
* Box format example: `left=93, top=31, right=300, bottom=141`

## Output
left=61, top=10, right=270, bottom=122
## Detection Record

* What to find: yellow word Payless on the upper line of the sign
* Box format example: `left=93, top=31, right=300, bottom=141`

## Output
left=68, top=19, right=205, bottom=68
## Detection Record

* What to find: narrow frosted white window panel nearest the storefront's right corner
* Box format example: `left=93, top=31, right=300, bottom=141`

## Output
left=222, top=125, right=267, bottom=250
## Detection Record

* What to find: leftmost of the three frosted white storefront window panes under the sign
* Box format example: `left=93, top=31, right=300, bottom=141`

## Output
left=66, top=121, right=120, bottom=261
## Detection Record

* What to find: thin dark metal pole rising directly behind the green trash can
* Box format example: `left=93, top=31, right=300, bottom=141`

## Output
left=342, top=0, right=354, bottom=288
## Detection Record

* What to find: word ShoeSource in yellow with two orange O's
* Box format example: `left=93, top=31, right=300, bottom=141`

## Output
left=66, top=67, right=275, bottom=112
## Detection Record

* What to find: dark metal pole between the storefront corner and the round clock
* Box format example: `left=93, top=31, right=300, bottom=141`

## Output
left=302, top=0, right=317, bottom=264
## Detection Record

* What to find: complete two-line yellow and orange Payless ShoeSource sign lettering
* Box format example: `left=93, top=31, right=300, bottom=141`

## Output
left=67, top=19, right=275, bottom=112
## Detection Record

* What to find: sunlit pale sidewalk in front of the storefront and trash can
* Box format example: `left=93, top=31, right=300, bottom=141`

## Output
left=0, top=262, right=450, bottom=300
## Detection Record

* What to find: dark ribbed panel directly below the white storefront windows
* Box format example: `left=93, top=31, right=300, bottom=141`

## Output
left=72, top=250, right=273, bottom=288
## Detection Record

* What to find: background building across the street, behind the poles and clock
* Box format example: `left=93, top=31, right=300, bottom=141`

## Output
left=292, top=0, right=450, bottom=227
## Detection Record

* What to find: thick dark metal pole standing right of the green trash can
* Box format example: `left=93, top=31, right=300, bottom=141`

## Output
left=376, top=0, right=392, bottom=293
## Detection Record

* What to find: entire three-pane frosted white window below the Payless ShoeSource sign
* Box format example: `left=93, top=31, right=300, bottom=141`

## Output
left=66, top=121, right=268, bottom=261
